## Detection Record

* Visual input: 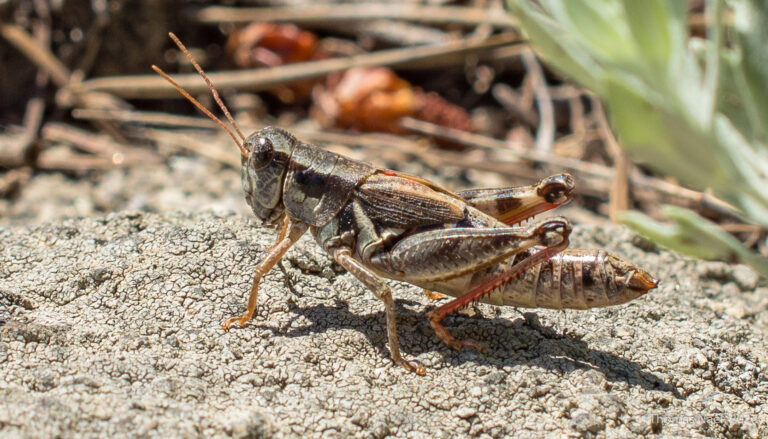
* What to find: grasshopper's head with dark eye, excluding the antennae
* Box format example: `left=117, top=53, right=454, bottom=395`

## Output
left=240, top=127, right=297, bottom=225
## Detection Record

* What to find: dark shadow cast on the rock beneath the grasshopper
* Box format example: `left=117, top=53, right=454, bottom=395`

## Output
left=257, top=299, right=680, bottom=398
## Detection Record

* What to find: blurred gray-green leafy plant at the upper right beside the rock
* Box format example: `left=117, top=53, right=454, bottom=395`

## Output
left=508, top=0, right=768, bottom=276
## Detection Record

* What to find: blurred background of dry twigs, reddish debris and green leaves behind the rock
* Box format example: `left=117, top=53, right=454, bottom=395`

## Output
left=0, top=0, right=768, bottom=276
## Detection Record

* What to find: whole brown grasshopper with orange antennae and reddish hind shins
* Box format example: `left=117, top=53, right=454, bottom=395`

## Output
left=153, top=34, right=658, bottom=375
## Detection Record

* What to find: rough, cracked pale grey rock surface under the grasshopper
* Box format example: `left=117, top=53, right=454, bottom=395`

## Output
left=0, top=213, right=768, bottom=438
